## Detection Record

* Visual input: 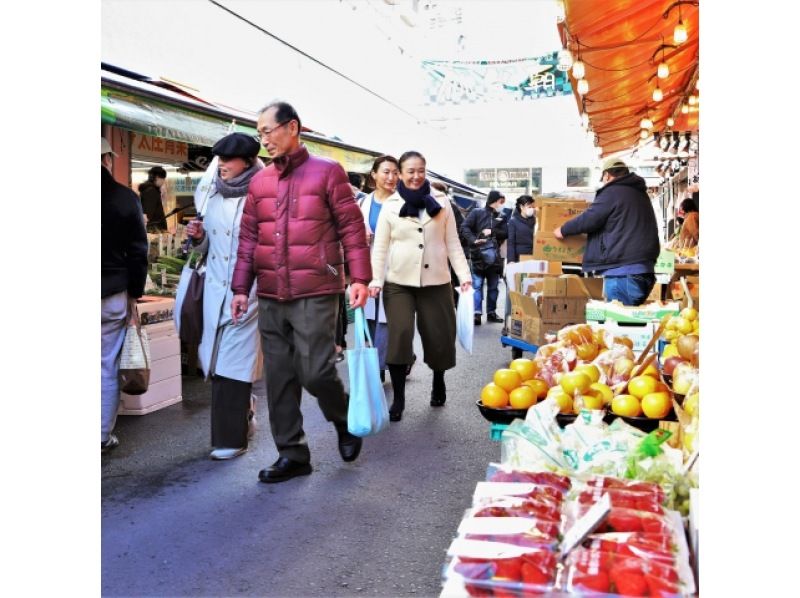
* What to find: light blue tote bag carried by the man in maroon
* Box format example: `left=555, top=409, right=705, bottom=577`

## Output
left=347, top=307, right=389, bottom=437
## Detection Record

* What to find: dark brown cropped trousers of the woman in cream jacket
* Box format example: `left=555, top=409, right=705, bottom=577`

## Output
left=383, top=282, right=456, bottom=371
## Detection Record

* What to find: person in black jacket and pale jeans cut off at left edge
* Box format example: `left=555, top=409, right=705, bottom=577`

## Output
left=100, top=137, right=147, bottom=453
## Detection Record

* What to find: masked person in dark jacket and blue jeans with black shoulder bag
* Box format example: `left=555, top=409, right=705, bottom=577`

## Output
left=461, top=190, right=508, bottom=326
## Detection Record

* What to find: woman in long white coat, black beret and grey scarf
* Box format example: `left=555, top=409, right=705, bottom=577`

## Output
left=186, top=133, right=264, bottom=459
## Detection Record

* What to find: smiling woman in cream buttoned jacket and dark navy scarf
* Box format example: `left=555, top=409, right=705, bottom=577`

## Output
left=370, top=151, right=472, bottom=421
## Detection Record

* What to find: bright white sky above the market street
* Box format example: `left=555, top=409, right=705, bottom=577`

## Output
left=101, top=0, right=597, bottom=178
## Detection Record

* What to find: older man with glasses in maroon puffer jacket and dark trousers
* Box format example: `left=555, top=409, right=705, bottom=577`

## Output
left=228, top=102, right=372, bottom=483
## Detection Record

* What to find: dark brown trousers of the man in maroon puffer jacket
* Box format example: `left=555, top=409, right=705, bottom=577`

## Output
left=258, top=295, right=347, bottom=463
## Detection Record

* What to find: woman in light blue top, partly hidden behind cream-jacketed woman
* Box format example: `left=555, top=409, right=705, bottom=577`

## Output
left=360, top=156, right=400, bottom=381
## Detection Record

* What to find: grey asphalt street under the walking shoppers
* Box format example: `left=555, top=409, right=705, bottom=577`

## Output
left=101, top=285, right=511, bottom=597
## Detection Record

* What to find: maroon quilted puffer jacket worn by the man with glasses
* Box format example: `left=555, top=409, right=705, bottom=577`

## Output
left=231, top=146, right=372, bottom=301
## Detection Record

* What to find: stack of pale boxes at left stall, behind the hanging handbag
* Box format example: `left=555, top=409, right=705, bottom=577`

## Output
left=119, top=296, right=183, bottom=415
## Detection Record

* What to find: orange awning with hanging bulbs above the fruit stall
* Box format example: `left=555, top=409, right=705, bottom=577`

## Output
left=558, top=0, right=700, bottom=156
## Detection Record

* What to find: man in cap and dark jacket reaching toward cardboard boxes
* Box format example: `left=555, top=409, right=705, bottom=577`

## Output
left=553, top=158, right=661, bottom=305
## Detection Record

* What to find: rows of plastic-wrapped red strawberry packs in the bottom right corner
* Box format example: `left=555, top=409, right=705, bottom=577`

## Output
left=442, top=464, right=695, bottom=598
